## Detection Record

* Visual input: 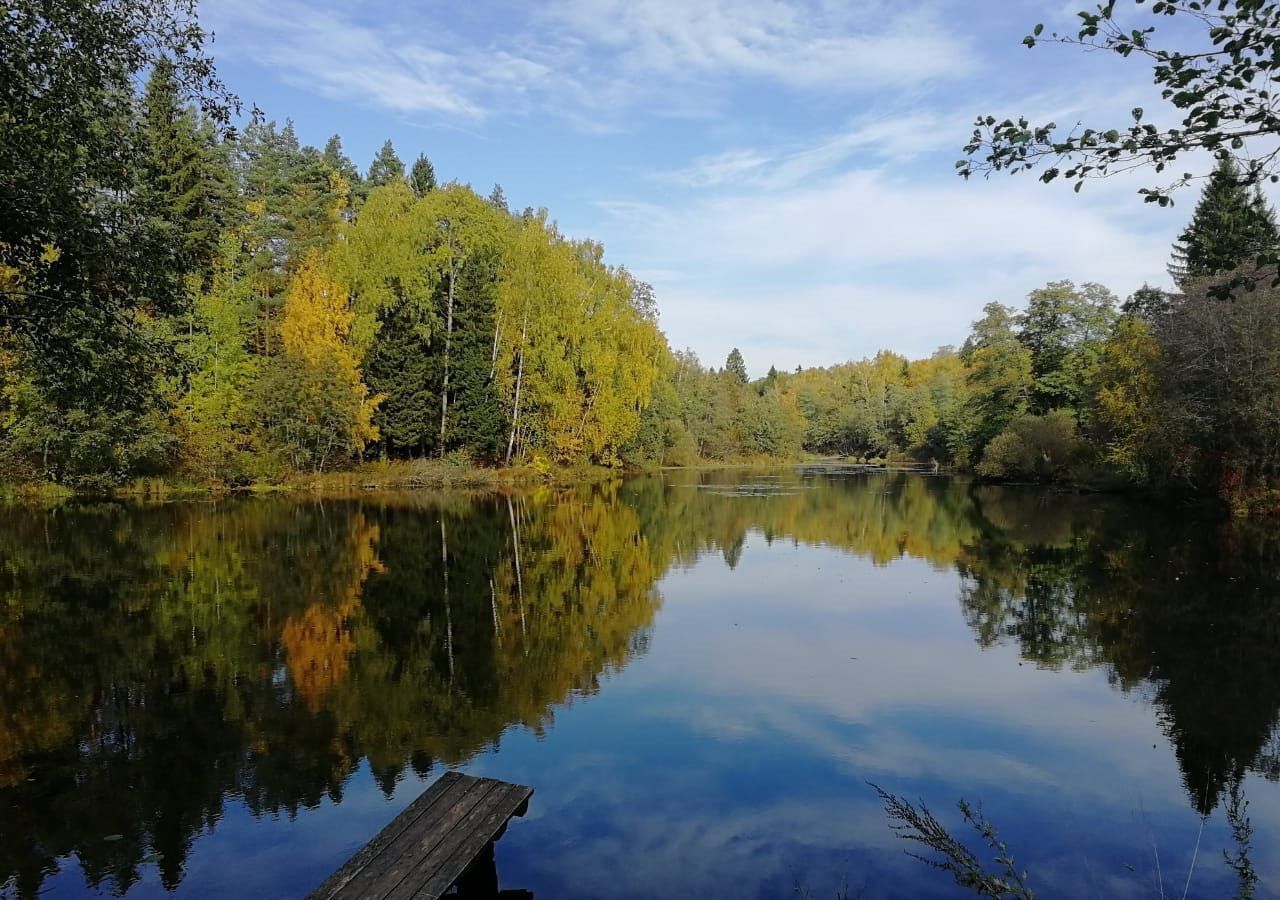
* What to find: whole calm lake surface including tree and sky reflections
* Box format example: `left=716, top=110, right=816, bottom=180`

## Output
left=0, top=471, right=1280, bottom=900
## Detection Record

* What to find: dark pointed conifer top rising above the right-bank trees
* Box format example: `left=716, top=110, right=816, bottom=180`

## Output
left=1169, top=159, right=1280, bottom=287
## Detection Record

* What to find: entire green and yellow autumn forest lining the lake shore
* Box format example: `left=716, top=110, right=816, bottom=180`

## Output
left=0, top=3, right=1280, bottom=512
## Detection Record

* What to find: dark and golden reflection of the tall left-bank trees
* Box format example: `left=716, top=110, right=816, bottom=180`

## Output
left=0, top=493, right=658, bottom=896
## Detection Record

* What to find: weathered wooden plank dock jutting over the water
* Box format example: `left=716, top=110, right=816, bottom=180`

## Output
left=308, top=772, right=534, bottom=900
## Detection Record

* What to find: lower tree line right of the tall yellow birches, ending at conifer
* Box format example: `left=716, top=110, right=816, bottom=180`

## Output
left=655, top=161, right=1280, bottom=511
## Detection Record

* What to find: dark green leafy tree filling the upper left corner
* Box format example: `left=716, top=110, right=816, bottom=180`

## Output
left=0, top=0, right=236, bottom=415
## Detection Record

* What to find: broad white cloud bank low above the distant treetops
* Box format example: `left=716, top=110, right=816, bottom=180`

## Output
left=604, top=138, right=1183, bottom=374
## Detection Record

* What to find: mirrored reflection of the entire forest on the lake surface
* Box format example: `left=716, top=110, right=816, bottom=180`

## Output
left=0, top=471, right=1280, bottom=896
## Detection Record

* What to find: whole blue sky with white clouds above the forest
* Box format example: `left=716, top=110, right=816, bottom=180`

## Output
left=201, top=0, right=1223, bottom=375
